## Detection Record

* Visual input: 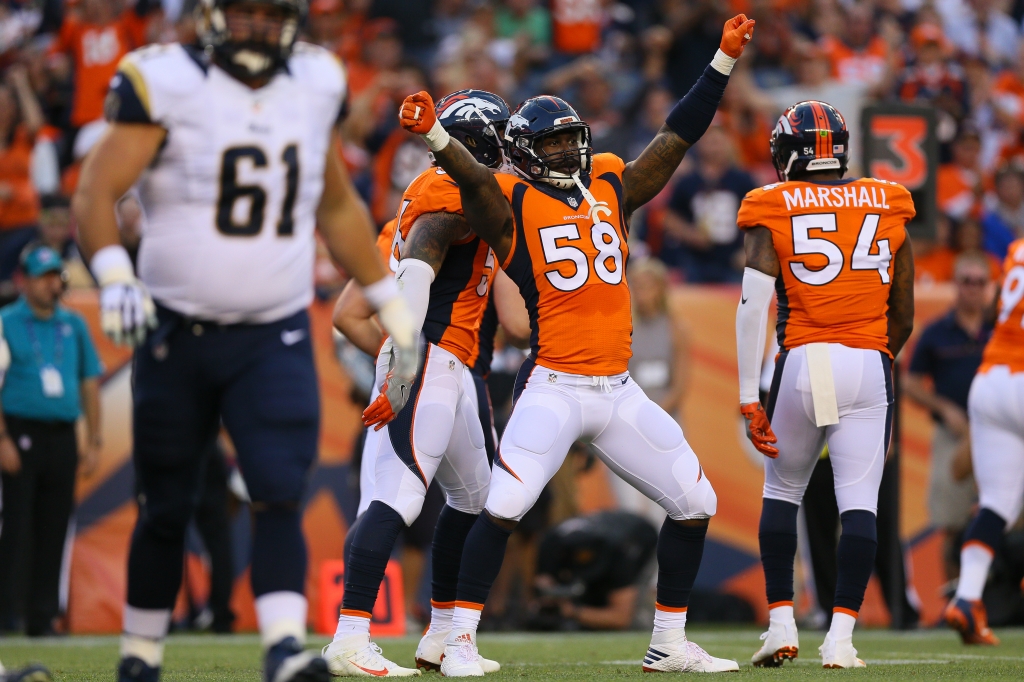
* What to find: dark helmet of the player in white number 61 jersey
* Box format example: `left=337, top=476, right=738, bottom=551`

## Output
left=196, top=0, right=309, bottom=79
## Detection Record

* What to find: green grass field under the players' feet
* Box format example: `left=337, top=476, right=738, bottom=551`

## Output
left=0, top=626, right=1024, bottom=682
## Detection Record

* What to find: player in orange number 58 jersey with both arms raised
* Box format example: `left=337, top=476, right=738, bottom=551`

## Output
left=400, top=14, right=754, bottom=677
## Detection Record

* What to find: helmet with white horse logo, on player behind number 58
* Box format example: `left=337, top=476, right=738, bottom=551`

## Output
left=434, top=89, right=509, bottom=168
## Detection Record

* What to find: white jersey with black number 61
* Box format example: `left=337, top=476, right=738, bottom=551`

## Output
left=106, top=43, right=346, bottom=324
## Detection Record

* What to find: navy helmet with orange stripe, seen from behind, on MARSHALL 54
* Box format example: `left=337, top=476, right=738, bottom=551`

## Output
left=770, top=99, right=850, bottom=182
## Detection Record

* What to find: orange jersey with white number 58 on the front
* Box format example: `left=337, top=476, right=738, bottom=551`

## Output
left=497, top=154, right=633, bottom=376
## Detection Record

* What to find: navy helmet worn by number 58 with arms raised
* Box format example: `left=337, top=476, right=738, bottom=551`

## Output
left=505, top=95, right=594, bottom=189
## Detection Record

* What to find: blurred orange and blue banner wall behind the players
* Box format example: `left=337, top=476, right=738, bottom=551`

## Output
left=67, top=287, right=951, bottom=633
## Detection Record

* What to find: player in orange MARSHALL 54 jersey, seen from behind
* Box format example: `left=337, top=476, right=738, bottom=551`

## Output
left=736, top=101, right=914, bottom=668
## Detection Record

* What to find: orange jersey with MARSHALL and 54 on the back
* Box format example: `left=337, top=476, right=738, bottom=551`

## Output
left=737, top=178, right=914, bottom=353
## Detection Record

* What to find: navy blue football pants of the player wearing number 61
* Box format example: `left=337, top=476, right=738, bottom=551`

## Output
left=128, top=306, right=319, bottom=609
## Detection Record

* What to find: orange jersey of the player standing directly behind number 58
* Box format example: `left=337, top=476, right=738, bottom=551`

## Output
left=385, top=168, right=498, bottom=367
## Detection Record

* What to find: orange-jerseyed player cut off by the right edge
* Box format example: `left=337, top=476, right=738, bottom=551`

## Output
left=945, top=240, right=1024, bottom=644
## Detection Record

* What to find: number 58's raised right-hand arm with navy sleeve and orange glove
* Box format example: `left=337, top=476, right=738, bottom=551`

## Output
left=623, top=14, right=754, bottom=214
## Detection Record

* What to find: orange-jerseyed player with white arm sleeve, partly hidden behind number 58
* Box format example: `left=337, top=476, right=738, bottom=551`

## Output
left=324, top=90, right=525, bottom=677
